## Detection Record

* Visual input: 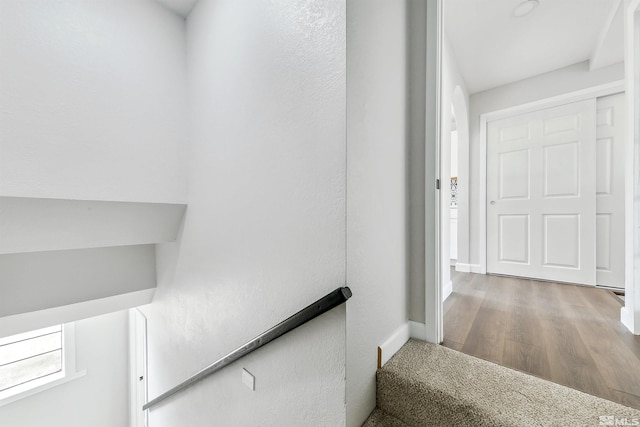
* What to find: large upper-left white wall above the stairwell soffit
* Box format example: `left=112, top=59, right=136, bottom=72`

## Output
left=0, top=0, right=187, bottom=202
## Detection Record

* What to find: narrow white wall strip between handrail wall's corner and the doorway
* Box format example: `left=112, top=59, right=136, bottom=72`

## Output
left=347, top=0, right=408, bottom=426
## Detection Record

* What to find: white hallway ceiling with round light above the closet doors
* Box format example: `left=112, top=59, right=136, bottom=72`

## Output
left=444, top=0, right=624, bottom=93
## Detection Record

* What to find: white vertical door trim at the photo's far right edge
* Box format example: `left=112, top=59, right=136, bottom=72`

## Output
left=620, top=0, right=640, bottom=335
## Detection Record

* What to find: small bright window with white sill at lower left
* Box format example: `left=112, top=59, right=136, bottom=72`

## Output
left=0, top=324, right=85, bottom=406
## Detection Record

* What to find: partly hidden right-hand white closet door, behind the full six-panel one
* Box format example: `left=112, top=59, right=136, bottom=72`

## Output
left=596, top=93, right=625, bottom=288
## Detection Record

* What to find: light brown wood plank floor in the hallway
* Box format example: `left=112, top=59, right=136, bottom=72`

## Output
left=443, top=271, right=640, bottom=409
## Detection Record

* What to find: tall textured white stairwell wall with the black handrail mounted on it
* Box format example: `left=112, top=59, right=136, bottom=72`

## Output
left=145, top=0, right=348, bottom=427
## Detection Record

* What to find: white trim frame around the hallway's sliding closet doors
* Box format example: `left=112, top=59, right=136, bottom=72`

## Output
left=478, top=80, right=624, bottom=274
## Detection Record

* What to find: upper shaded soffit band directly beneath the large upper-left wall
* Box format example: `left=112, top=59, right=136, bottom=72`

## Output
left=0, top=196, right=186, bottom=255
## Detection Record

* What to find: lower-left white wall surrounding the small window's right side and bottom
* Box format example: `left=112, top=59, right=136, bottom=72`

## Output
left=0, top=311, right=129, bottom=427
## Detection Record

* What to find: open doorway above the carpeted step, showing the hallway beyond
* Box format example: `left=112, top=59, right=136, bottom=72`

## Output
left=438, top=0, right=640, bottom=407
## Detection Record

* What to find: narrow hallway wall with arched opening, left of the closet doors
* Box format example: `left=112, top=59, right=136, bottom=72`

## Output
left=440, top=35, right=469, bottom=288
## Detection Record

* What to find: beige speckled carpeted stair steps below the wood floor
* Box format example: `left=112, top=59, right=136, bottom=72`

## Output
left=363, top=340, right=640, bottom=427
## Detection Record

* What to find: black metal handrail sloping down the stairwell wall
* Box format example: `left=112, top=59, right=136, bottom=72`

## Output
left=142, top=287, right=352, bottom=410
